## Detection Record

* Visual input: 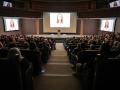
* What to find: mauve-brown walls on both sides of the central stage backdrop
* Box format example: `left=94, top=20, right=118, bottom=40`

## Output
left=0, top=18, right=98, bottom=35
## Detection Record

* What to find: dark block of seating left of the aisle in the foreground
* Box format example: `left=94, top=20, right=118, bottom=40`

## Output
left=0, top=43, right=51, bottom=90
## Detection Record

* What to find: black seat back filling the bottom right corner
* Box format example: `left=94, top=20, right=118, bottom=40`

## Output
left=94, top=56, right=120, bottom=90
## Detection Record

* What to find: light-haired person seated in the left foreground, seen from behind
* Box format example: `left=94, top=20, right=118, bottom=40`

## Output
left=7, top=48, right=33, bottom=88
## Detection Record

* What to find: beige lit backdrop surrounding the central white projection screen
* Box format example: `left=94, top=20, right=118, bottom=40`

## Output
left=43, top=12, right=77, bottom=34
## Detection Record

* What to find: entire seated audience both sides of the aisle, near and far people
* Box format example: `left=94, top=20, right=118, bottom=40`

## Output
left=0, top=33, right=120, bottom=90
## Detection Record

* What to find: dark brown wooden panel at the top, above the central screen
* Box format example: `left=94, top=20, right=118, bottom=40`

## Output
left=32, top=1, right=95, bottom=11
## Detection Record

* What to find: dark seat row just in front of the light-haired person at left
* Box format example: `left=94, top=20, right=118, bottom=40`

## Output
left=0, top=48, right=49, bottom=75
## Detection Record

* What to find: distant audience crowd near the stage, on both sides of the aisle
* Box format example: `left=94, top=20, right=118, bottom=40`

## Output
left=0, top=33, right=120, bottom=74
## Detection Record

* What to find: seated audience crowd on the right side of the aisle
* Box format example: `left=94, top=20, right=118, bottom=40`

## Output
left=64, top=32, right=120, bottom=75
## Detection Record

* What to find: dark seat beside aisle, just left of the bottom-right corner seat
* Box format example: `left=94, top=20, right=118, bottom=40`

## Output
left=76, top=50, right=99, bottom=90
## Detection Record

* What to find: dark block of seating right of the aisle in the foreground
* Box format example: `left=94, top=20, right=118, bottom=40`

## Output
left=64, top=43, right=120, bottom=90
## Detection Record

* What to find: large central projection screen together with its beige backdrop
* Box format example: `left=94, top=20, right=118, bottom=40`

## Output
left=43, top=12, right=77, bottom=33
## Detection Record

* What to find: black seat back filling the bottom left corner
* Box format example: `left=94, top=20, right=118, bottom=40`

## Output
left=0, top=56, right=23, bottom=90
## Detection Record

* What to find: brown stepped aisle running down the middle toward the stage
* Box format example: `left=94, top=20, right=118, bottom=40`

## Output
left=34, top=43, right=81, bottom=90
